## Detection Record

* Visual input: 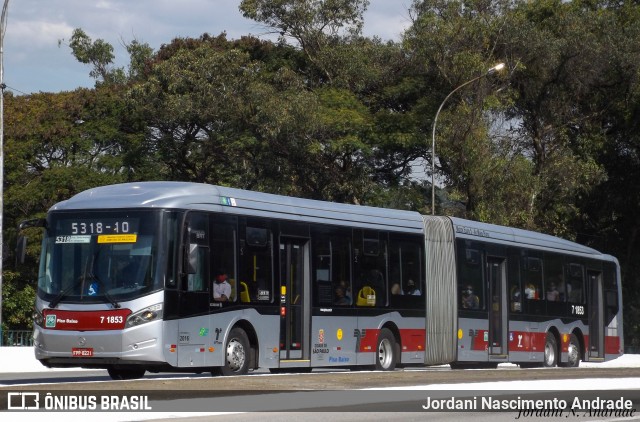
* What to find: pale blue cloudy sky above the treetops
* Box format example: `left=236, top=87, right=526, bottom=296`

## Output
left=2, top=0, right=412, bottom=95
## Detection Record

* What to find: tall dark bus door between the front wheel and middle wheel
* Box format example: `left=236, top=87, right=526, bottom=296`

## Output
left=280, top=238, right=310, bottom=362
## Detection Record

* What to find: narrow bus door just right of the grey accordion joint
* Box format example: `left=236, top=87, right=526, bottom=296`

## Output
left=487, top=257, right=508, bottom=356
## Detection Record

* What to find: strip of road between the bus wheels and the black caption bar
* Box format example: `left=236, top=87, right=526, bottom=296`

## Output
left=0, top=366, right=640, bottom=394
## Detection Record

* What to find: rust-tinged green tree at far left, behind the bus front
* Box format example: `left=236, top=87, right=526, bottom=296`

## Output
left=3, top=87, right=153, bottom=328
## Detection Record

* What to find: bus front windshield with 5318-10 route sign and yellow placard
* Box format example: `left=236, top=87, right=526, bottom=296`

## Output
left=38, top=211, right=168, bottom=308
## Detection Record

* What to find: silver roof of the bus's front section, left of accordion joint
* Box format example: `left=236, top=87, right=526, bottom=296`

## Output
left=51, top=182, right=423, bottom=233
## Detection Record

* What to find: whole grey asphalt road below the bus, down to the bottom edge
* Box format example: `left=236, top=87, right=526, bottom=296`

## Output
left=0, top=367, right=640, bottom=422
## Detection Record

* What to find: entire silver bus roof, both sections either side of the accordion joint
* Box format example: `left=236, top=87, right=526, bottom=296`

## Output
left=50, top=182, right=615, bottom=260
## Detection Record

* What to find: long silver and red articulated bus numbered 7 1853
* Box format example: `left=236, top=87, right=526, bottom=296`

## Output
left=21, top=182, right=623, bottom=379
